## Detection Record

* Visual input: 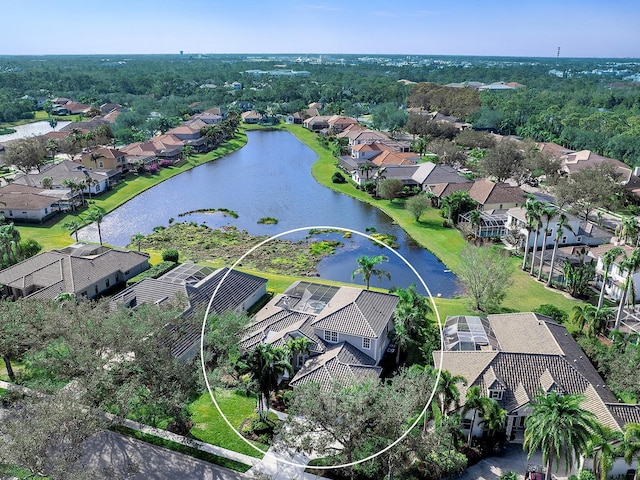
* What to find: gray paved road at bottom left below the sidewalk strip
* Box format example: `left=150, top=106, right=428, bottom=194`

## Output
left=80, top=431, right=253, bottom=480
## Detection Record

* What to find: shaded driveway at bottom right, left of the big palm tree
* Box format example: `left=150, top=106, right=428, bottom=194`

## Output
left=457, top=444, right=542, bottom=480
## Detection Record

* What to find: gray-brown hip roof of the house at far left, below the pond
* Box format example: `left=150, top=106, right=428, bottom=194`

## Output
left=0, top=246, right=149, bottom=299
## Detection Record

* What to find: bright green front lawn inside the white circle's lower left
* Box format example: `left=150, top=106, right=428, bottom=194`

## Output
left=189, top=390, right=269, bottom=458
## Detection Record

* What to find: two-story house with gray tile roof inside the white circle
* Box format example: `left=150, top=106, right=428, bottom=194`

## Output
left=240, top=281, right=398, bottom=387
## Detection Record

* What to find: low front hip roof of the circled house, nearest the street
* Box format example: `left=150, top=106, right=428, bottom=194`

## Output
left=289, top=342, right=382, bottom=387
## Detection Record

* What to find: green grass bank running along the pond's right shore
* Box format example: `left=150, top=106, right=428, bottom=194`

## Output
left=282, top=125, right=581, bottom=320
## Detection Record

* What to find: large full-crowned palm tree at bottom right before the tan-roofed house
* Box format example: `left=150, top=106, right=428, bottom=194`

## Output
left=523, top=391, right=597, bottom=477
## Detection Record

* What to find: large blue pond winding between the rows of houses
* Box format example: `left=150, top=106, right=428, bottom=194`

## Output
left=79, top=131, right=460, bottom=297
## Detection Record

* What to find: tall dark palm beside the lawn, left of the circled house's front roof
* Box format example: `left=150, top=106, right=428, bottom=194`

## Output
left=246, top=343, right=293, bottom=422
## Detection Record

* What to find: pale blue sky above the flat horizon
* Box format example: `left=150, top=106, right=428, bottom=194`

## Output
left=0, top=0, right=640, bottom=58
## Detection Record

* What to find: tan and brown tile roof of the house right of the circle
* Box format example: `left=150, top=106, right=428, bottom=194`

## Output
left=434, top=313, right=624, bottom=430
